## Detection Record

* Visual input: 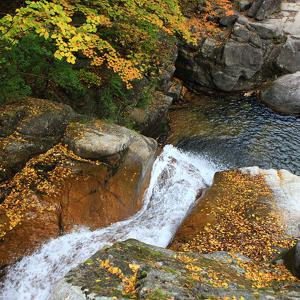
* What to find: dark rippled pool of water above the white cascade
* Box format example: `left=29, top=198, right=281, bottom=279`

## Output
left=170, top=95, right=300, bottom=175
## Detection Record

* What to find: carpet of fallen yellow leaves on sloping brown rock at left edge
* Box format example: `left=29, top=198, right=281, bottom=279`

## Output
left=0, top=144, right=97, bottom=238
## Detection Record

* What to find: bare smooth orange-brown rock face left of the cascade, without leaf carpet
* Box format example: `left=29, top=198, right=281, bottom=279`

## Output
left=59, top=158, right=146, bottom=232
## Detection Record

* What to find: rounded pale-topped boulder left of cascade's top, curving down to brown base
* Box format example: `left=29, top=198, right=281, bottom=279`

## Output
left=64, top=120, right=157, bottom=210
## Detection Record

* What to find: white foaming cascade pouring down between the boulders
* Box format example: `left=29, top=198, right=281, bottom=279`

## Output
left=0, top=145, right=217, bottom=300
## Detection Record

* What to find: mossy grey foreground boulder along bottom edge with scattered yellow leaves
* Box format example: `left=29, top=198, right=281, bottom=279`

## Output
left=50, top=240, right=300, bottom=300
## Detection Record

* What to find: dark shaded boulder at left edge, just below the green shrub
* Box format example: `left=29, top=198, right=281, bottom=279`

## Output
left=0, top=98, right=75, bottom=182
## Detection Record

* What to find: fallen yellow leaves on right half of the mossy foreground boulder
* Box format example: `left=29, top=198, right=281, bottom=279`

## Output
left=175, top=253, right=299, bottom=290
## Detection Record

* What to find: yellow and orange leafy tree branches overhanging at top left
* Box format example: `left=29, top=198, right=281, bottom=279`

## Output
left=0, top=0, right=190, bottom=88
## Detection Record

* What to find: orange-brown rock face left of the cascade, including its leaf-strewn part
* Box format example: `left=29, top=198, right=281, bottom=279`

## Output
left=0, top=146, right=155, bottom=266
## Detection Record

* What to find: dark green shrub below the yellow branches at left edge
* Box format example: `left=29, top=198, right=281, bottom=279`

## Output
left=0, top=34, right=85, bottom=102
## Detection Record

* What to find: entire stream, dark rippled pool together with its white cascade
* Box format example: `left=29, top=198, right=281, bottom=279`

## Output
left=0, top=92, right=300, bottom=300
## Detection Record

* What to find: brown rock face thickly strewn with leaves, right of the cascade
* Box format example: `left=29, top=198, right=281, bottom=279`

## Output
left=171, top=171, right=293, bottom=261
